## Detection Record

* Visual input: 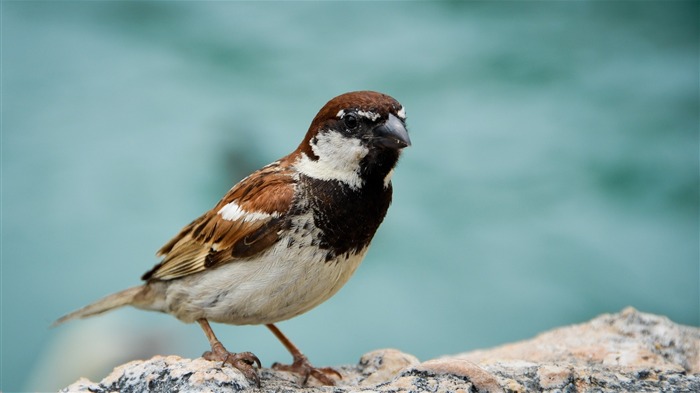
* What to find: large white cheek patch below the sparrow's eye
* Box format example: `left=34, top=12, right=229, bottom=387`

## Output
left=295, top=131, right=369, bottom=189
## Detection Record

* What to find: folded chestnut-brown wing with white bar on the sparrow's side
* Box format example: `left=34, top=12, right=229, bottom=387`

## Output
left=142, top=163, right=295, bottom=280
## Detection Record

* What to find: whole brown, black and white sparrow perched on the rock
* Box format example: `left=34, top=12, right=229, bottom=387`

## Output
left=55, top=91, right=411, bottom=386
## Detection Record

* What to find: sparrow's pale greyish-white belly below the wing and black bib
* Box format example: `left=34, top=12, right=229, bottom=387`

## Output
left=165, top=239, right=367, bottom=325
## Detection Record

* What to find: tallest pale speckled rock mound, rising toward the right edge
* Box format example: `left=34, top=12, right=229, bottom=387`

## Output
left=447, top=308, right=700, bottom=392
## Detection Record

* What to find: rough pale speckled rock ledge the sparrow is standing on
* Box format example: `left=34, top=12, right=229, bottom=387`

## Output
left=62, top=308, right=700, bottom=393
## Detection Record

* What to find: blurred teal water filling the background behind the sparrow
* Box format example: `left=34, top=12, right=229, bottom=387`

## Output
left=0, top=1, right=700, bottom=391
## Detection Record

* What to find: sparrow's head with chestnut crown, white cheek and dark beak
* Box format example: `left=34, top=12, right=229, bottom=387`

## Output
left=294, top=91, right=411, bottom=189
